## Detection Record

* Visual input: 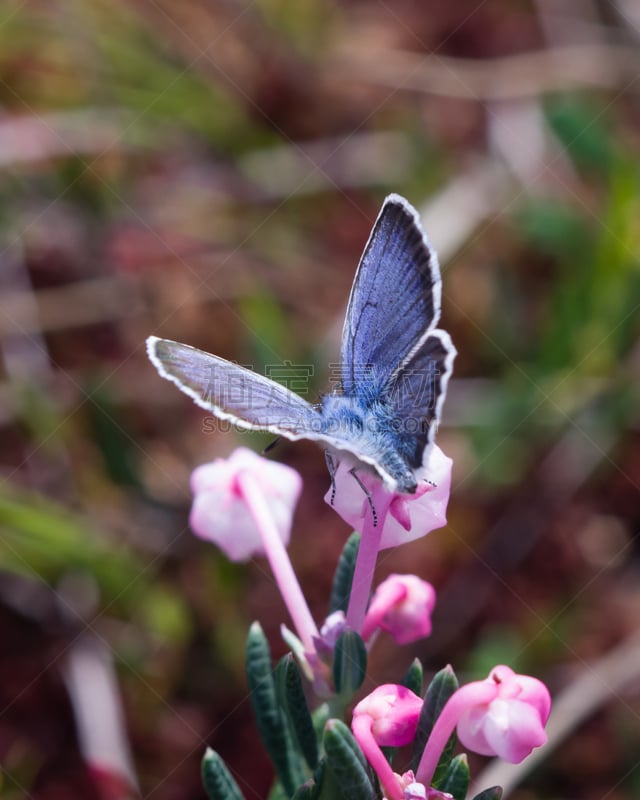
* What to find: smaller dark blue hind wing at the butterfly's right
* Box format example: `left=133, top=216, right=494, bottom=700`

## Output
left=384, top=329, right=456, bottom=470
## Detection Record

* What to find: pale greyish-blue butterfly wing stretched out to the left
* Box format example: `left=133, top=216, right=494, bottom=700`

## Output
left=147, top=336, right=323, bottom=440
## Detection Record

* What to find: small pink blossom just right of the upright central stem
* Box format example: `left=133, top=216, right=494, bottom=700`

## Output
left=361, top=574, right=436, bottom=644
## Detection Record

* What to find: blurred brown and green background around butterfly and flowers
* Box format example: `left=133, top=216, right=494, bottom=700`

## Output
left=0, top=0, right=640, bottom=800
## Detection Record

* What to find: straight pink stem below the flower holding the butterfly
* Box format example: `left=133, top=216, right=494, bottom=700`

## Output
left=347, top=492, right=393, bottom=631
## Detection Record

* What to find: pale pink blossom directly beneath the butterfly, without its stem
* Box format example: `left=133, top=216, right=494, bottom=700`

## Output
left=324, top=445, right=453, bottom=550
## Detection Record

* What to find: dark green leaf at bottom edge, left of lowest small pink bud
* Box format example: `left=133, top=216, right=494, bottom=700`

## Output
left=321, top=719, right=376, bottom=800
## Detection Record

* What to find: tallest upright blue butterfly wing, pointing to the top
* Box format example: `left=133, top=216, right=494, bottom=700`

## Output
left=341, top=194, right=441, bottom=395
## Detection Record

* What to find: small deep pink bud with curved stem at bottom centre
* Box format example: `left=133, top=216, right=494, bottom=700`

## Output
left=351, top=683, right=422, bottom=800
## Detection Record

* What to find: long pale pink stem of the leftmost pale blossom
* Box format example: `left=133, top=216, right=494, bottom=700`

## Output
left=236, top=470, right=319, bottom=653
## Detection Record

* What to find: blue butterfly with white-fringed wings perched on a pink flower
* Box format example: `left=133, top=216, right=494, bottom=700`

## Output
left=147, top=194, right=456, bottom=494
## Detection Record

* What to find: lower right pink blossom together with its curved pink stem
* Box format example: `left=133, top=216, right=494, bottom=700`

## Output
left=417, top=666, right=551, bottom=785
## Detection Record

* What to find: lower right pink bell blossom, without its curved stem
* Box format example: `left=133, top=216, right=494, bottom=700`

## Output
left=458, top=666, right=551, bottom=764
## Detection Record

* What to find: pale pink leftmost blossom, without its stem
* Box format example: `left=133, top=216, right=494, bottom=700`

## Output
left=189, top=447, right=302, bottom=561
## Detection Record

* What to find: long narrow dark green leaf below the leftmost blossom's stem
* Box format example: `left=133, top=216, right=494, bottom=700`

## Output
left=246, top=622, right=306, bottom=797
